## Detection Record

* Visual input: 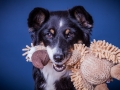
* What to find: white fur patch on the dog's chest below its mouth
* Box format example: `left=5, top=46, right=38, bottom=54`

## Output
left=41, top=63, right=69, bottom=90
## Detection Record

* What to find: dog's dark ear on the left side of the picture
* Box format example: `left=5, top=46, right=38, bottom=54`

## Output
left=28, top=7, right=49, bottom=32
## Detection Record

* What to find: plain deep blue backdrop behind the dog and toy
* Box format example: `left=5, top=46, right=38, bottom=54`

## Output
left=0, top=0, right=120, bottom=90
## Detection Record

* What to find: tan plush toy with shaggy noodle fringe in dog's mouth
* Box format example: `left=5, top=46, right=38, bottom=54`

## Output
left=23, top=40, right=120, bottom=90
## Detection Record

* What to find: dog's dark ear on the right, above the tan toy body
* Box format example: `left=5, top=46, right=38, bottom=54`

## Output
left=69, top=6, right=93, bottom=28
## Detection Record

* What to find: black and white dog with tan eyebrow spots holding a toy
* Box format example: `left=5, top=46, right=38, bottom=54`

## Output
left=28, top=6, right=93, bottom=90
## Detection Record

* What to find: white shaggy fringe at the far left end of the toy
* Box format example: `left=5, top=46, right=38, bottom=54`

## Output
left=22, top=43, right=36, bottom=62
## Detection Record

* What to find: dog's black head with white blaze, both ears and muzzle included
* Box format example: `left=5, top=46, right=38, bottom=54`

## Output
left=28, top=6, right=93, bottom=71
